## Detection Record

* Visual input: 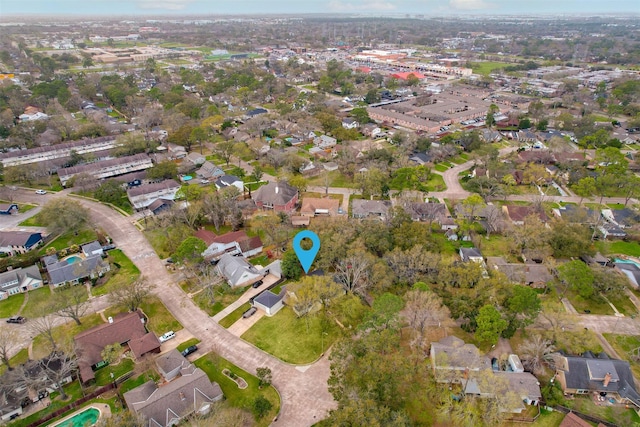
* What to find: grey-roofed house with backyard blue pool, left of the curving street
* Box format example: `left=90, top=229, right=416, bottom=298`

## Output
left=42, top=249, right=111, bottom=288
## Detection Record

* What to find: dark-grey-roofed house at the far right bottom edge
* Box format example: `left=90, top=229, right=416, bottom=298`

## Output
left=555, top=353, right=640, bottom=410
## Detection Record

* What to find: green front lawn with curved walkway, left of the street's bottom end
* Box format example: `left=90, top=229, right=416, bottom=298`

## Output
left=194, top=353, right=280, bottom=427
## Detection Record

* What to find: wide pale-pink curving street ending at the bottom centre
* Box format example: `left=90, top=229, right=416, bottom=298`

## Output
left=75, top=200, right=336, bottom=427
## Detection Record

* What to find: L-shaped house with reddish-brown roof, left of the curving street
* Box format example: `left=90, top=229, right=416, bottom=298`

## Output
left=73, top=311, right=160, bottom=384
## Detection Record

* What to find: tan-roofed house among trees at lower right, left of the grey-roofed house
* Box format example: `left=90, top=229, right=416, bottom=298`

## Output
left=430, top=335, right=491, bottom=383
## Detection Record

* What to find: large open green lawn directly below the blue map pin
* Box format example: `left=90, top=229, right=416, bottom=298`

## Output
left=242, top=306, right=339, bottom=364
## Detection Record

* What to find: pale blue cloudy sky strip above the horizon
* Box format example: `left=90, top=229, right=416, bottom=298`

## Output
left=0, top=0, right=640, bottom=18
